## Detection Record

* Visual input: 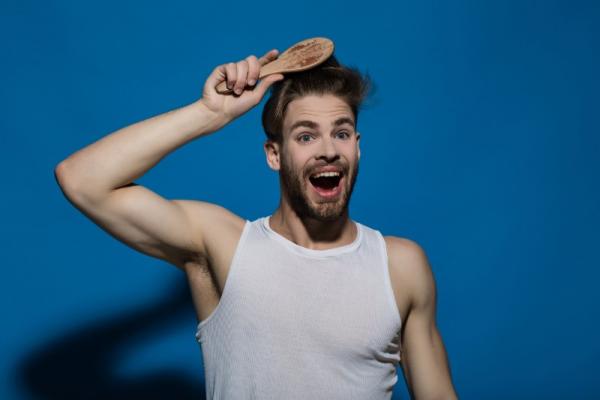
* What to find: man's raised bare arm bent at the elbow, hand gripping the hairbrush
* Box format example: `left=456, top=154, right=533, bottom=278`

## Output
left=55, top=50, right=283, bottom=268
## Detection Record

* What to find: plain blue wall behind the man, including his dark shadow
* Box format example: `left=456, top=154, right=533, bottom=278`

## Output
left=0, top=0, right=600, bottom=399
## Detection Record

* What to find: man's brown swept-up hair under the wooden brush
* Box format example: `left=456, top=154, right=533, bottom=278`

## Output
left=262, top=55, right=372, bottom=144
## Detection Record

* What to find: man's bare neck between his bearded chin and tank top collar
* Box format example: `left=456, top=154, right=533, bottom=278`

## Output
left=269, top=201, right=358, bottom=250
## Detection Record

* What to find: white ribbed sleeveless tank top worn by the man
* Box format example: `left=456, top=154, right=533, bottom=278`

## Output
left=196, top=217, right=401, bottom=400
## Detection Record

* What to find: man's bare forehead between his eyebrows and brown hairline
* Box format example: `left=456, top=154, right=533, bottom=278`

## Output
left=283, top=94, right=354, bottom=132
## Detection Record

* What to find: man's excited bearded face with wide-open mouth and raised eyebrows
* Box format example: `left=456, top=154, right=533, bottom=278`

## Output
left=271, top=95, right=360, bottom=221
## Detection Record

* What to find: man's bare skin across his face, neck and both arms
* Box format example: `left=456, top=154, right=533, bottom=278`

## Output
left=55, top=50, right=457, bottom=399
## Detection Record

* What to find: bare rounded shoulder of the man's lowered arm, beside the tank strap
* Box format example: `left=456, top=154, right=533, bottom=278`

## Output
left=384, top=236, right=435, bottom=310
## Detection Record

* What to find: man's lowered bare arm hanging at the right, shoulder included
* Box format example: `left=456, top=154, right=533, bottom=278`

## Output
left=386, top=236, right=457, bottom=400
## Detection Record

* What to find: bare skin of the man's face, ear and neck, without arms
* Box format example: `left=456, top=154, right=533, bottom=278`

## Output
left=264, top=95, right=360, bottom=249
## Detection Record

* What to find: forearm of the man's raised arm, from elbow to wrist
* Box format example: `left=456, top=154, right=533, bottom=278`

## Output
left=56, top=100, right=224, bottom=198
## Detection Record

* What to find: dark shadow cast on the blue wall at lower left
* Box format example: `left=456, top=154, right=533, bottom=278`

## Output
left=18, top=284, right=205, bottom=400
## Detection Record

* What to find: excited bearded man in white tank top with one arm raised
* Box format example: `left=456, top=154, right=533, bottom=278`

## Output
left=55, top=50, right=456, bottom=399
